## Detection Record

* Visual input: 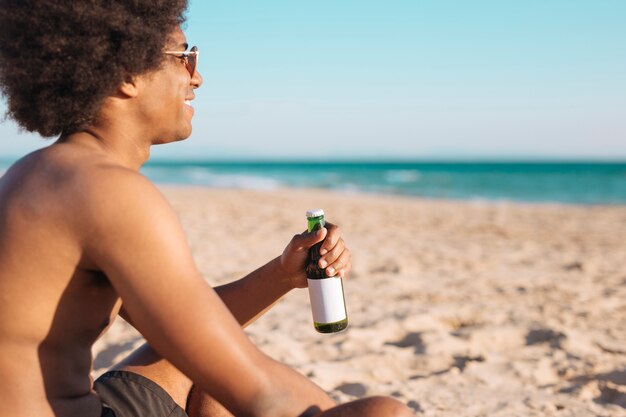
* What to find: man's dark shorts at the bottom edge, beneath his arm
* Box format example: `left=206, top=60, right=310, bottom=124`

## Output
left=93, top=371, right=188, bottom=417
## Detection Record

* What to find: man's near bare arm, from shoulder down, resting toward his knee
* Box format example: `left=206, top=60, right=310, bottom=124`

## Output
left=81, top=169, right=334, bottom=416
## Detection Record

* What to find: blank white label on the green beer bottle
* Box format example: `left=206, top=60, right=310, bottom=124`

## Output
left=308, top=277, right=347, bottom=323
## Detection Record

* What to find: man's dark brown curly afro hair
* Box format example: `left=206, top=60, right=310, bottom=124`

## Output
left=0, top=0, right=187, bottom=137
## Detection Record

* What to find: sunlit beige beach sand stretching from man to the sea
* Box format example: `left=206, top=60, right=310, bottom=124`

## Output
left=94, top=187, right=626, bottom=417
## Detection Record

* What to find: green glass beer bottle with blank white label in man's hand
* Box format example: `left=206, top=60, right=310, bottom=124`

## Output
left=306, top=209, right=348, bottom=333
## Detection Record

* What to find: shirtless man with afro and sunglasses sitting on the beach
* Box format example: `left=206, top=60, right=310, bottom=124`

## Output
left=0, top=0, right=411, bottom=417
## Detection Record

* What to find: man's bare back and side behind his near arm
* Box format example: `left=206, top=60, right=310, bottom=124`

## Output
left=0, top=145, right=126, bottom=417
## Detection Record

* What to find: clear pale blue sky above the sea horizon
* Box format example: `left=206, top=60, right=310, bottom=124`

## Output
left=0, top=0, right=626, bottom=160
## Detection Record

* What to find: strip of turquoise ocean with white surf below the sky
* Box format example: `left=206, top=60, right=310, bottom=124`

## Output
left=0, top=161, right=626, bottom=204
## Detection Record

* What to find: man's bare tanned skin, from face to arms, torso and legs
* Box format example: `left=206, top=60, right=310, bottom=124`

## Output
left=0, top=30, right=412, bottom=417
